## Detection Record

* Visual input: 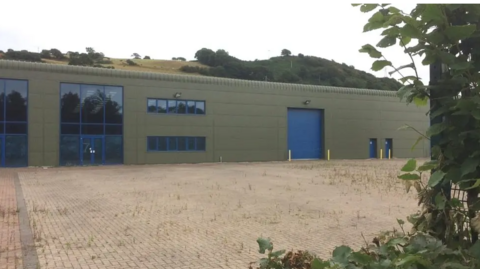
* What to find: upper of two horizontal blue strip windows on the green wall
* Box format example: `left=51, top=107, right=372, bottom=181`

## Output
left=147, top=98, right=205, bottom=115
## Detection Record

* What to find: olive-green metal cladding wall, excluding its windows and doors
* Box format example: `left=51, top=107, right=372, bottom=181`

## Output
left=0, top=61, right=429, bottom=166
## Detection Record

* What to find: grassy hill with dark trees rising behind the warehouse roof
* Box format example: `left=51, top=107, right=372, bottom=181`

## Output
left=0, top=48, right=401, bottom=91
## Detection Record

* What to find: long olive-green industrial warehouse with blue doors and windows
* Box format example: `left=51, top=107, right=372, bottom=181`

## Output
left=0, top=61, right=429, bottom=167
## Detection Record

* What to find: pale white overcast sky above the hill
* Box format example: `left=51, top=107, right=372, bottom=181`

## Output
left=0, top=0, right=428, bottom=83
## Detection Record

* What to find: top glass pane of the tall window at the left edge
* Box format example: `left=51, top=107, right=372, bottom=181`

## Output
left=5, top=80, right=27, bottom=121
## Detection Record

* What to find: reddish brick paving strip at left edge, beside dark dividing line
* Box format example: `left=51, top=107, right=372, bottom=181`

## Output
left=0, top=169, right=22, bottom=269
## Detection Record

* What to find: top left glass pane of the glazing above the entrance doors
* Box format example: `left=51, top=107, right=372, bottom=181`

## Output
left=60, top=83, right=80, bottom=122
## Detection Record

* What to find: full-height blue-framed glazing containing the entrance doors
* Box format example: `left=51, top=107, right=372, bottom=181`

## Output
left=60, top=83, right=124, bottom=166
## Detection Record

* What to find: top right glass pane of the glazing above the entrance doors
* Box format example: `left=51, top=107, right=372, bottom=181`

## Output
left=105, top=86, right=123, bottom=123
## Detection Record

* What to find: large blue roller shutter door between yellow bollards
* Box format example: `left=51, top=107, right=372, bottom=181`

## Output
left=288, top=108, right=323, bottom=159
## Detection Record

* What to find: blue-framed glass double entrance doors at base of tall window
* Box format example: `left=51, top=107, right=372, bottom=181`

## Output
left=80, top=136, right=105, bottom=165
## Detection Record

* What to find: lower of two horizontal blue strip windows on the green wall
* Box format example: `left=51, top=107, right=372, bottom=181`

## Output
left=147, top=136, right=205, bottom=151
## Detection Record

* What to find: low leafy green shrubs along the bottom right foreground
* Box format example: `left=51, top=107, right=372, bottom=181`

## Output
left=249, top=233, right=480, bottom=269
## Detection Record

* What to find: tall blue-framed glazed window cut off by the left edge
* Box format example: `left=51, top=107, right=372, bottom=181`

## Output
left=0, top=79, right=28, bottom=167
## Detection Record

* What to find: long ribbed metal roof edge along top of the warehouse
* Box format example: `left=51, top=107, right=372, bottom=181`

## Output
left=0, top=60, right=396, bottom=97
